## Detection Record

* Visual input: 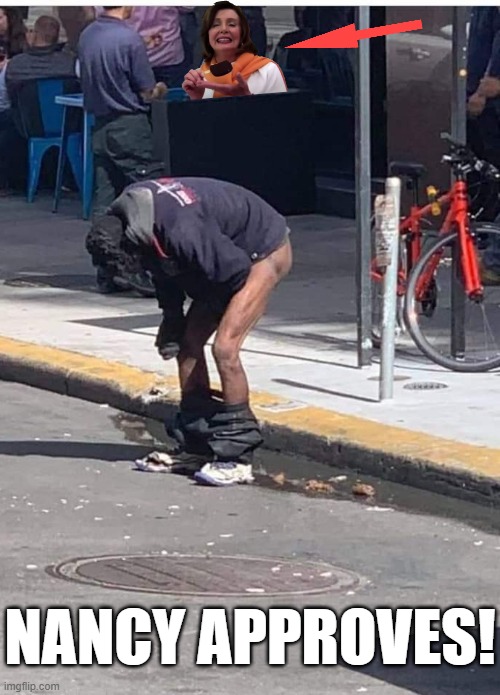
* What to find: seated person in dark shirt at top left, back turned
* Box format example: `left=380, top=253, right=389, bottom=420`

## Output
left=5, top=15, right=75, bottom=105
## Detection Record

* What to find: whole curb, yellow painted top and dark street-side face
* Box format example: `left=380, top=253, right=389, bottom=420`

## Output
left=0, top=337, right=500, bottom=507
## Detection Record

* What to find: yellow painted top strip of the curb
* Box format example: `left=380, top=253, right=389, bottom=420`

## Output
left=0, top=337, right=500, bottom=478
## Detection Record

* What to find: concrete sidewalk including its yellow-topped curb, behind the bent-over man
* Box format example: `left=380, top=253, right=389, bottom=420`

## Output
left=0, top=198, right=500, bottom=504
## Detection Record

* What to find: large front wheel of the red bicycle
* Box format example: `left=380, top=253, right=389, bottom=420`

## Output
left=405, top=226, right=500, bottom=372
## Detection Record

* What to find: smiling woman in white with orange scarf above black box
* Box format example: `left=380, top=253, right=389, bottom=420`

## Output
left=182, top=0, right=287, bottom=99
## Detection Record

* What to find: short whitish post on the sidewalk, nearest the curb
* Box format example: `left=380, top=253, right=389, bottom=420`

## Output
left=377, top=177, right=401, bottom=401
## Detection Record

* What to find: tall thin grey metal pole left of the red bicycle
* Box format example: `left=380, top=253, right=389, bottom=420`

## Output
left=355, top=7, right=372, bottom=367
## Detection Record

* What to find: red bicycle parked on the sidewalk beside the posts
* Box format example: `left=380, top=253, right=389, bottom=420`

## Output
left=371, top=135, right=500, bottom=372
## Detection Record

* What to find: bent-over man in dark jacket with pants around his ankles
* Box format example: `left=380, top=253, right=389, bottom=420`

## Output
left=87, top=178, right=292, bottom=486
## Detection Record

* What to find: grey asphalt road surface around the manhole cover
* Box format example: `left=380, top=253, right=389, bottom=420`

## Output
left=0, top=383, right=500, bottom=695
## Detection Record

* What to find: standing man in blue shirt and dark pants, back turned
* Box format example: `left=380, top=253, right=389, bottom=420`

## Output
left=78, top=7, right=166, bottom=292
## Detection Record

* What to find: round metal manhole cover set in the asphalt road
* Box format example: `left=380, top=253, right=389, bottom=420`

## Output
left=47, top=555, right=359, bottom=596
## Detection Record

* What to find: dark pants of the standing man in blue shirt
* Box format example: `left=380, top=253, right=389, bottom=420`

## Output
left=93, top=113, right=162, bottom=215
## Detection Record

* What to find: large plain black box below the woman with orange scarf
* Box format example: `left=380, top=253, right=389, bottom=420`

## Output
left=152, top=91, right=315, bottom=215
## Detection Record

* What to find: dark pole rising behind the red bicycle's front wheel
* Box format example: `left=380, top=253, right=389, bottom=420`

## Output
left=450, top=7, right=469, bottom=357
